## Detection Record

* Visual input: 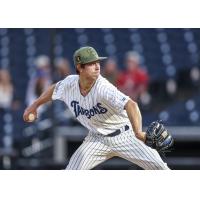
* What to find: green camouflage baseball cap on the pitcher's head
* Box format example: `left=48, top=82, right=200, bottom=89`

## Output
left=74, top=47, right=107, bottom=66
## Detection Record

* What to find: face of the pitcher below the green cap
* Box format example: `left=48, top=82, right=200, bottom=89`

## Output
left=79, top=61, right=100, bottom=79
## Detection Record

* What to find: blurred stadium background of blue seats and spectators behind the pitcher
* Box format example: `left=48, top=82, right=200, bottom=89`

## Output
left=0, top=28, right=200, bottom=169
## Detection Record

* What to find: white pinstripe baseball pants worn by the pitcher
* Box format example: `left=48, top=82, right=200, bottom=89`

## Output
left=66, top=129, right=169, bottom=170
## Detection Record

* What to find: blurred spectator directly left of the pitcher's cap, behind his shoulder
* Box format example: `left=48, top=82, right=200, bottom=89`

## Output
left=54, top=58, right=71, bottom=82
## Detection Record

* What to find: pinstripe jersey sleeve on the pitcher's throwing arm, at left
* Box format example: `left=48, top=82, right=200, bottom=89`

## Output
left=52, top=79, right=66, bottom=101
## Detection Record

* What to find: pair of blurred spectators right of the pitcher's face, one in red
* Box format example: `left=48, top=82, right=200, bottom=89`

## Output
left=102, top=51, right=150, bottom=105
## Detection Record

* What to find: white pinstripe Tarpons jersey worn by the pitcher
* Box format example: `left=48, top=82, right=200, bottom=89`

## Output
left=52, top=75, right=130, bottom=135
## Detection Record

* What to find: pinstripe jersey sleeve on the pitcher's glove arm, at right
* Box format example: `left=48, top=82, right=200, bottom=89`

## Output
left=102, top=81, right=130, bottom=112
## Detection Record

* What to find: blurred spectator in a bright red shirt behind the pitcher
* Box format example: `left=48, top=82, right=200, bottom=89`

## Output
left=117, top=51, right=149, bottom=103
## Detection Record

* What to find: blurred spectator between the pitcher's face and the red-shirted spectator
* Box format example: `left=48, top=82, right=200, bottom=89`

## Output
left=103, top=58, right=118, bottom=85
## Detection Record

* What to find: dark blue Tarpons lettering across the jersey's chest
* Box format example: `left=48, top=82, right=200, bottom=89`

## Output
left=71, top=101, right=108, bottom=119
